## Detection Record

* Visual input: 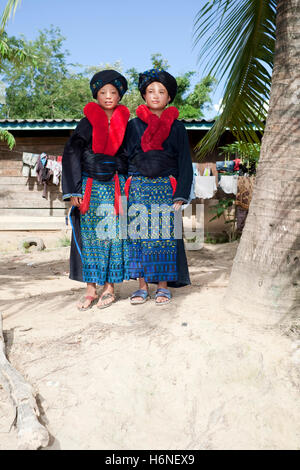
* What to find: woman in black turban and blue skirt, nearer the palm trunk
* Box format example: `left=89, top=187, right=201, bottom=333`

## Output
left=125, top=68, right=193, bottom=305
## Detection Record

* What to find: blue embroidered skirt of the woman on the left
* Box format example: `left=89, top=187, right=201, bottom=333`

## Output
left=80, top=175, right=129, bottom=285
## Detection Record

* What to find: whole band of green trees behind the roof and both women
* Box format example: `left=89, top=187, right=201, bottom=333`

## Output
left=0, top=26, right=215, bottom=119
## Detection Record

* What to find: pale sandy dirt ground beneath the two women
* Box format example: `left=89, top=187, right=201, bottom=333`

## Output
left=0, top=233, right=300, bottom=450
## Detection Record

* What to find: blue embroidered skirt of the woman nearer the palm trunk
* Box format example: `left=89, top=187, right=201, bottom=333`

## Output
left=128, top=176, right=178, bottom=282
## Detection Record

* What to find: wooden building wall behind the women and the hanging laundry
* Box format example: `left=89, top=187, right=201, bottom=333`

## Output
left=0, top=130, right=232, bottom=234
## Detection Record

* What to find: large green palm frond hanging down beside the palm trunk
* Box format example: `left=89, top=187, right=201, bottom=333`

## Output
left=194, top=0, right=277, bottom=158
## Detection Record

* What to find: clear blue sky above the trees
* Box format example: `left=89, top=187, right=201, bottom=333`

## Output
left=0, top=0, right=221, bottom=118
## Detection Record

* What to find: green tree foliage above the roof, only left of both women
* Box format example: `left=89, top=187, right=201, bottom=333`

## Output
left=1, top=27, right=90, bottom=119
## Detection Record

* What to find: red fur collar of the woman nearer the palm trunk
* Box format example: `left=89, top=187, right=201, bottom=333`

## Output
left=136, top=104, right=179, bottom=152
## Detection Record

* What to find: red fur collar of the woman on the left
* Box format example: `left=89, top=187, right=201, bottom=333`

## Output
left=83, top=102, right=130, bottom=155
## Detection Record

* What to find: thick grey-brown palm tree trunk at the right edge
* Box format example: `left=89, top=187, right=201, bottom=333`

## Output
left=225, top=0, right=300, bottom=326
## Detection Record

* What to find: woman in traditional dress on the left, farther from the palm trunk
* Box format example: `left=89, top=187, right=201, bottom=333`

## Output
left=62, top=70, right=130, bottom=310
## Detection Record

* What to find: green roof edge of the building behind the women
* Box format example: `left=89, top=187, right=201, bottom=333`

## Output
left=0, top=119, right=215, bottom=131
